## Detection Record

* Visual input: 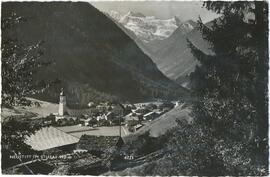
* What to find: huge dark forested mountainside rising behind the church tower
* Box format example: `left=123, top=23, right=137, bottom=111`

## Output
left=2, top=2, right=189, bottom=104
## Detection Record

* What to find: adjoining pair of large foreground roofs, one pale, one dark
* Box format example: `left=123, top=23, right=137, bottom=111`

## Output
left=25, top=126, right=124, bottom=154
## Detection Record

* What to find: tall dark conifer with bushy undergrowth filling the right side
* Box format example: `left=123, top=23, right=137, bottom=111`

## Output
left=167, top=1, right=268, bottom=175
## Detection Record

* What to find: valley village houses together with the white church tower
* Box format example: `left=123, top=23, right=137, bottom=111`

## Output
left=52, top=90, right=179, bottom=132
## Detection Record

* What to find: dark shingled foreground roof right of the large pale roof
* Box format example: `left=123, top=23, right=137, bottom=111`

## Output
left=77, top=135, right=123, bottom=151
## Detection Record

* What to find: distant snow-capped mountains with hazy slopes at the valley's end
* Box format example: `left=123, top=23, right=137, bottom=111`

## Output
left=107, top=11, right=211, bottom=87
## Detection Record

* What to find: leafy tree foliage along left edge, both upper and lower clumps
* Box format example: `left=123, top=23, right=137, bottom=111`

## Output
left=1, top=13, right=49, bottom=168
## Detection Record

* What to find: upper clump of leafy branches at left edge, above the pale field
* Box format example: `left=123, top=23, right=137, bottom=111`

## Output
left=1, top=13, right=49, bottom=107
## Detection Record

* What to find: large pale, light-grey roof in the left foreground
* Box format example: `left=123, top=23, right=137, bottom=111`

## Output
left=25, top=127, right=79, bottom=151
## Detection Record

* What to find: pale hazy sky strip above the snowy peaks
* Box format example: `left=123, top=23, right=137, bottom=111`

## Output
left=90, top=1, right=217, bottom=22
